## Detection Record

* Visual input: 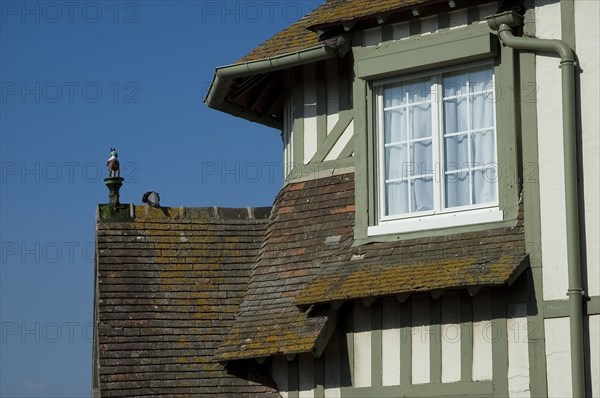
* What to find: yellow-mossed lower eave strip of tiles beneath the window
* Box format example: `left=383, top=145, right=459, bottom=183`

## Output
left=296, top=254, right=529, bottom=307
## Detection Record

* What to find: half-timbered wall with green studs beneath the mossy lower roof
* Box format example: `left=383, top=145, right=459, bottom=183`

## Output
left=272, top=289, right=529, bottom=398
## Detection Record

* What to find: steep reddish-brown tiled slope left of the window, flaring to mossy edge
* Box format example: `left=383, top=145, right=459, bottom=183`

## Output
left=218, top=175, right=354, bottom=360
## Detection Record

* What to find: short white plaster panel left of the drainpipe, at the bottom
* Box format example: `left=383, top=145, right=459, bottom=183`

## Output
left=544, top=318, right=572, bottom=398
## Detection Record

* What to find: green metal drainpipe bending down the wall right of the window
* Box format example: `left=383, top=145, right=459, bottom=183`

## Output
left=486, top=11, right=585, bottom=397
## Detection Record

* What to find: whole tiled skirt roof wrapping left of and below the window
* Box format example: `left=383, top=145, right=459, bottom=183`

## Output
left=217, top=174, right=527, bottom=360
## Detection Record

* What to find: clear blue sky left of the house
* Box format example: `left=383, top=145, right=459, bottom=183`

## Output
left=0, top=0, right=318, bottom=397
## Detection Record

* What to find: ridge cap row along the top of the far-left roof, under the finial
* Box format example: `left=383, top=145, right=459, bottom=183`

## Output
left=97, top=204, right=272, bottom=222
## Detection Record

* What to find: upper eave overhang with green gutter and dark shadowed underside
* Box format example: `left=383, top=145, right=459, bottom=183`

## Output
left=204, top=36, right=350, bottom=129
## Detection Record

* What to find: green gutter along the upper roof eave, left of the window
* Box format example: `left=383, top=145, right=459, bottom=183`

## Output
left=204, top=36, right=350, bottom=120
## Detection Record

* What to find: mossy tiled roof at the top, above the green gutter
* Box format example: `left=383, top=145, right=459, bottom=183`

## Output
left=238, top=0, right=432, bottom=63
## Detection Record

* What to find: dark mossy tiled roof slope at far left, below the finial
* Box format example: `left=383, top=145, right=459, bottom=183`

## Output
left=96, top=206, right=279, bottom=397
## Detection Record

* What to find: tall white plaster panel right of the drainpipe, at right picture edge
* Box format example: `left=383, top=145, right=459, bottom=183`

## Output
left=575, top=1, right=600, bottom=296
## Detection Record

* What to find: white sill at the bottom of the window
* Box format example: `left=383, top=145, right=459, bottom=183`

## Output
left=367, top=207, right=504, bottom=236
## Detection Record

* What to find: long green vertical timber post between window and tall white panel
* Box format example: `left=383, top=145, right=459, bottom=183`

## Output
left=515, top=44, right=548, bottom=397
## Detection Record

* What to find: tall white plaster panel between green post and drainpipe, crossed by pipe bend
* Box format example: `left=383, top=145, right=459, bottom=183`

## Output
left=536, top=1, right=568, bottom=300
